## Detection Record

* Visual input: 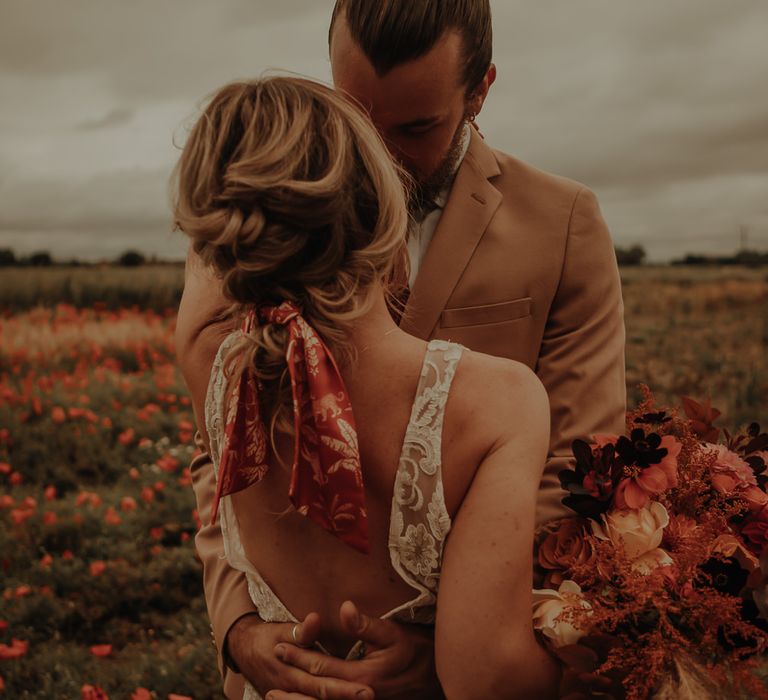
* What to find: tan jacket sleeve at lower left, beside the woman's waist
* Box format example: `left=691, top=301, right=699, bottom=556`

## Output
left=190, top=433, right=257, bottom=680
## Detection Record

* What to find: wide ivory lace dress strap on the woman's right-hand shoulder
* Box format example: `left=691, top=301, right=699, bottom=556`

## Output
left=389, top=340, right=463, bottom=622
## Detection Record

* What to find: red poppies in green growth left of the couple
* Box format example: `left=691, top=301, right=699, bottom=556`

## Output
left=0, top=305, right=221, bottom=699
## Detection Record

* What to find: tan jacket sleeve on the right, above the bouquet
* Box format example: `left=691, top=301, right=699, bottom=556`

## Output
left=536, top=188, right=626, bottom=527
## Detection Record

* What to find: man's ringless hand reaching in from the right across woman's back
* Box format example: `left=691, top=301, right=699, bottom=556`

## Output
left=269, top=601, right=444, bottom=700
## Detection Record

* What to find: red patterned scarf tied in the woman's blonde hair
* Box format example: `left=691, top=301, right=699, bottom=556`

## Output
left=211, top=301, right=369, bottom=554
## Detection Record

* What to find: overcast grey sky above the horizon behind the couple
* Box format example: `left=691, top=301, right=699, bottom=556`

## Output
left=0, top=0, right=768, bottom=260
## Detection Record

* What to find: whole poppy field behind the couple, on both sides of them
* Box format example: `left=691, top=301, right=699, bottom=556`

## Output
left=0, top=266, right=768, bottom=700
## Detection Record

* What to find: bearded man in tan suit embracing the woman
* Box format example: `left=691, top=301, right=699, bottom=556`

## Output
left=178, top=0, right=625, bottom=700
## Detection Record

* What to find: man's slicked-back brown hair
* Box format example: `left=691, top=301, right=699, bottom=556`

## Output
left=328, top=0, right=493, bottom=93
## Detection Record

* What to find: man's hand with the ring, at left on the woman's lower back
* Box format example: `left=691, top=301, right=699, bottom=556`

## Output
left=227, top=613, right=374, bottom=700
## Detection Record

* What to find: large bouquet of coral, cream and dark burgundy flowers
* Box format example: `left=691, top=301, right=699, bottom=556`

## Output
left=533, top=387, right=768, bottom=700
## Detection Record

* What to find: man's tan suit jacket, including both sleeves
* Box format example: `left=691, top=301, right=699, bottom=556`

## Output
left=183, top=130, right=626, bottom=697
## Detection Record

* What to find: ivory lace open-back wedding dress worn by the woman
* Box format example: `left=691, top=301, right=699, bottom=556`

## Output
left=205, top=331, right=463, bottom=700
